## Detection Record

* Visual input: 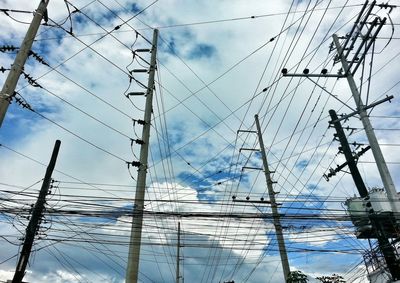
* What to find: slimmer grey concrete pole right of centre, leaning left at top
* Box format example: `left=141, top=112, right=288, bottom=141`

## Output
left=254, top=115, right=290, bottom=282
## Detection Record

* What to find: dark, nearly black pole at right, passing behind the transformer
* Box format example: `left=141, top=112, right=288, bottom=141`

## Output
left=329, top=110, right=400, bottom=280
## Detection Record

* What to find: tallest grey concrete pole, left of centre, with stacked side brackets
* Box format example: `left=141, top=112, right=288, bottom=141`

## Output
left=126, top=29, right=158, bottom=283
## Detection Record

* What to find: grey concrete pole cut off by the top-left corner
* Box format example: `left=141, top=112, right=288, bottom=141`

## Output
left=0, top=0, right=49, bottom=127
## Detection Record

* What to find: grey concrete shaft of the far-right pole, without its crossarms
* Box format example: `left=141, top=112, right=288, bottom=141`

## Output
left=332, top=34, right=399, bottom=212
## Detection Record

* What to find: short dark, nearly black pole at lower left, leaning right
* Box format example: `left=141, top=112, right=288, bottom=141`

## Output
left=12, top=140, right=61, bottom=283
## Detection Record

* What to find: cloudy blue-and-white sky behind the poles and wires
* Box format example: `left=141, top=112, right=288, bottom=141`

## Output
left=0, top=0, right=400, bottom=283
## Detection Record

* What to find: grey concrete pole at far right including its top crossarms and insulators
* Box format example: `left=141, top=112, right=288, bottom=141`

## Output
left=282, top=1, right=400, bottom=213
